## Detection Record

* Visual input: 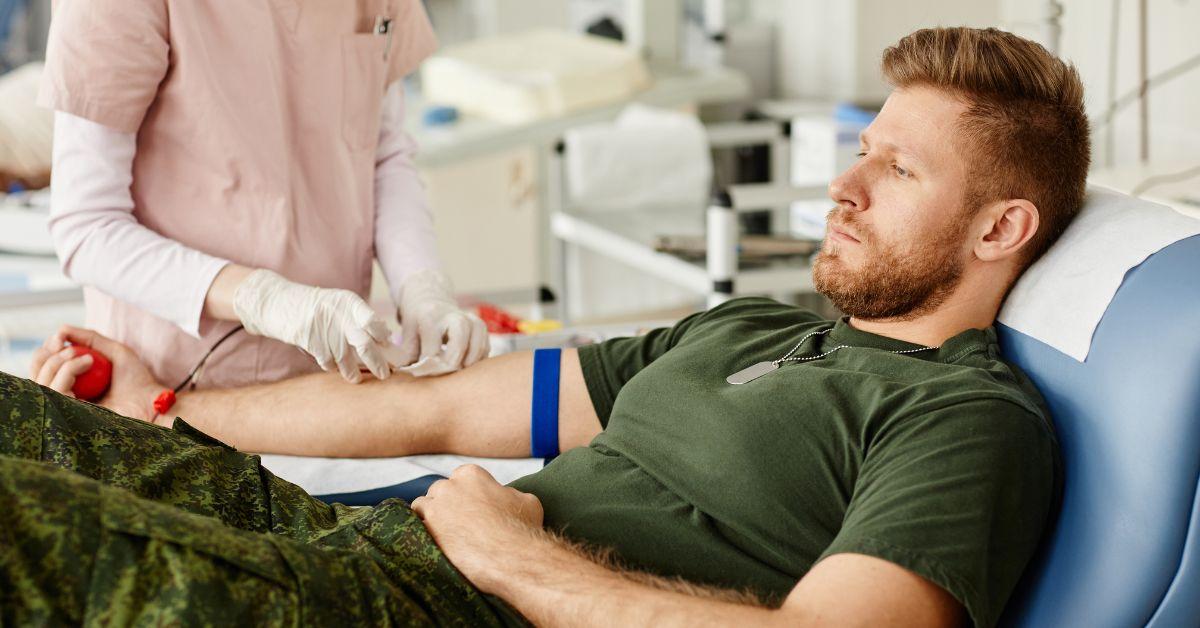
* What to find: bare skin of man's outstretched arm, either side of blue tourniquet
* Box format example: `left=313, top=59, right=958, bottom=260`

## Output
left=168, top=351, right=600, bottom=457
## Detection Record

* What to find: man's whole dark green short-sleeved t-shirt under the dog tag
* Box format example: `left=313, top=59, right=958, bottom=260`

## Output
left=512, top=299, right=1057, bottom=626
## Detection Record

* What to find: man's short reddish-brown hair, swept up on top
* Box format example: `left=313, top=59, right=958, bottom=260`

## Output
left=882, top=28, right=1091, bottom=268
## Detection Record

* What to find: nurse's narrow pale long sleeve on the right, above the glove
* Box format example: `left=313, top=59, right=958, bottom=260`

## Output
left=374, top=80, right=440, bottom=304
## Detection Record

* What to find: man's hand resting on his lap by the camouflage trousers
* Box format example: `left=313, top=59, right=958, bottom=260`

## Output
left=413, top=465, right=542, bottom=593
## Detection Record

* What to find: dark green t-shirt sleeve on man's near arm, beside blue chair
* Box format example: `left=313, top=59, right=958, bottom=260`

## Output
left=821, top=399, right=1056, bottom=626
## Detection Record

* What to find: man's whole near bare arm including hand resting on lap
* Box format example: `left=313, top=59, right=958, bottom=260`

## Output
left=413, top=465, right=966, bottom=627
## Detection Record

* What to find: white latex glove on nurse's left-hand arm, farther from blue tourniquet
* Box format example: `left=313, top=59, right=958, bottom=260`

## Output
left=233, top=269, right=391, bottom=383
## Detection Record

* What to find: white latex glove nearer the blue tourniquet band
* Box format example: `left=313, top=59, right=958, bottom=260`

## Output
left=392, top=270, right=490, bottom=376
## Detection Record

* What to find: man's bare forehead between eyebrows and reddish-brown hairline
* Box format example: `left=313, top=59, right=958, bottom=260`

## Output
left=862, top=88, right=966, bottom=166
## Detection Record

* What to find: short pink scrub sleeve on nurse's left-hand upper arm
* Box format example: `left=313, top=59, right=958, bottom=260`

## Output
left=38, top=0, right=170, bottom=133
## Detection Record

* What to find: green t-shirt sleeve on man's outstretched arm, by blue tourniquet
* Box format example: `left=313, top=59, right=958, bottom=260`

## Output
left=580, top=312, right=707, bottom=427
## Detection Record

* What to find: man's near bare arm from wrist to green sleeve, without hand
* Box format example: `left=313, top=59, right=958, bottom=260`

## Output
left=482, top=531, right=966, bottom=628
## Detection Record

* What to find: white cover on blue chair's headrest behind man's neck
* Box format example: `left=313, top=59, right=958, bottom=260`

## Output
left=997, top=186, right=1200, bottom=361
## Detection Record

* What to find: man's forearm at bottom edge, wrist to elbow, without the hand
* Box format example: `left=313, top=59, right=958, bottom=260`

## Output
left=476, top=531, right=798, bottom=627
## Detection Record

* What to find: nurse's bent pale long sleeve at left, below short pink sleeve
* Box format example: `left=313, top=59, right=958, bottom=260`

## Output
left=50, top=112, right=229, bottom=337
